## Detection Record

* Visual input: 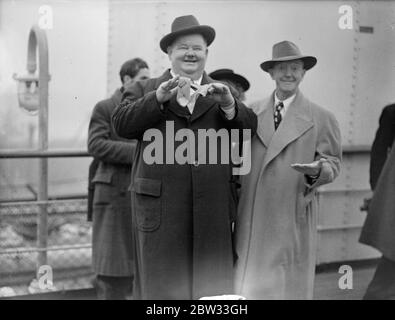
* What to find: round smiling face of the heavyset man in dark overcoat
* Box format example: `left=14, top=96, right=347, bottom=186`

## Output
left=167, top=34, right=208, bottom=80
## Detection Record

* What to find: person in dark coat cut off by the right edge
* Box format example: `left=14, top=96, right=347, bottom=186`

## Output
left=359, top=104, right=395, bottom=300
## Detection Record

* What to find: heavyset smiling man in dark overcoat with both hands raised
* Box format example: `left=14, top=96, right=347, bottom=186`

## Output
left=113, top=16, right=256, bottom=299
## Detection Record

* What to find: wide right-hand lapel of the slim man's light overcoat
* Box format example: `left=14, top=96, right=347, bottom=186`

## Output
left=262, top=92, right=314, bottom=168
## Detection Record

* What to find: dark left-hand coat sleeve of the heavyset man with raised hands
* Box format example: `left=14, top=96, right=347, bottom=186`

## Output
left=112, top=82, right=165, bottom=139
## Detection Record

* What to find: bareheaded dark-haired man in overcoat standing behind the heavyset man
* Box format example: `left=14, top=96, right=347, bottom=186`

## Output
left=88, top=58, right=149, bottom=299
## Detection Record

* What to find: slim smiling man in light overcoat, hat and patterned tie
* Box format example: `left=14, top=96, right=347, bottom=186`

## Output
left=235, top=41, right=341, bottom=299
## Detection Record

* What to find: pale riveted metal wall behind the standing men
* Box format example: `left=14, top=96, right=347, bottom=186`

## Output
left=108, top=1, right=395, bottom=263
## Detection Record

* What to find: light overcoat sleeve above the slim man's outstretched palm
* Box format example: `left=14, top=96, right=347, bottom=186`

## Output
left=308, top=112, right=342, bottom=188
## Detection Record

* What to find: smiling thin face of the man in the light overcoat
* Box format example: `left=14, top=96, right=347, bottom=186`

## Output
left=269, top=60, right=306, bottom=100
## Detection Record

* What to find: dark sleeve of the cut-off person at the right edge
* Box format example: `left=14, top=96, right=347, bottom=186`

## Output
left=369, top=105, right=395, bottom=190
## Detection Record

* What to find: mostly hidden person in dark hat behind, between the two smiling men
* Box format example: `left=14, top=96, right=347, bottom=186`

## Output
left=209, top=69, right=250, bottom=101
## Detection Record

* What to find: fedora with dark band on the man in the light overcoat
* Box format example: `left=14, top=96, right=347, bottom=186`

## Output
left=261, top=41, right=317, bottom=72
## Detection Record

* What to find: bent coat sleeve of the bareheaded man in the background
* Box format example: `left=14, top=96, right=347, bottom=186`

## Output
left=88, top=102, right=136, bottom=164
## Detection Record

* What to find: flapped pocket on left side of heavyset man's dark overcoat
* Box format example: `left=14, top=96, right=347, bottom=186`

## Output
left=132, top=178, right=162, bottom=231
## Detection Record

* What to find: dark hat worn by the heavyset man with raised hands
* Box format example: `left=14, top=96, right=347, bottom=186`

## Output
left=160, top=15, right=215, bottom=53
